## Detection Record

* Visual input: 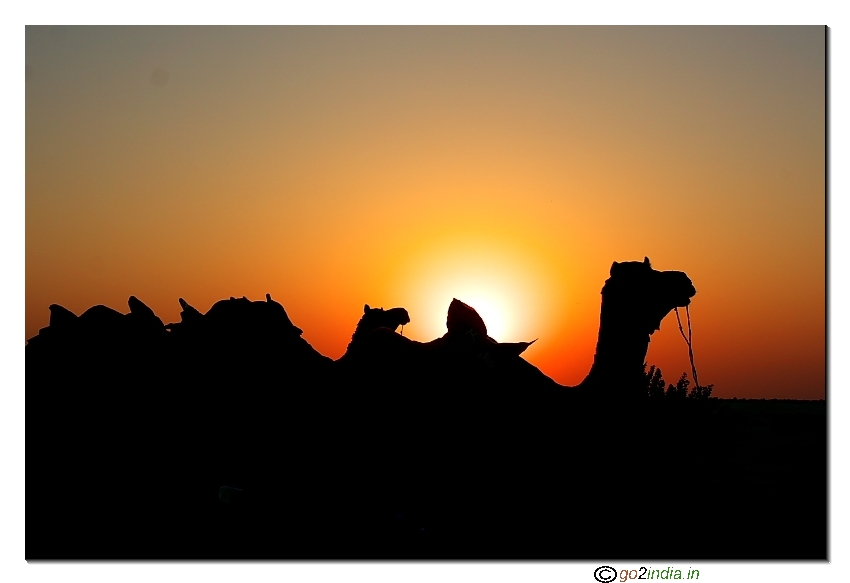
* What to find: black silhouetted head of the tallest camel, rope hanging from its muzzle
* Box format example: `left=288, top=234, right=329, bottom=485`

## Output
left=602, top=257, right=696, bottom=334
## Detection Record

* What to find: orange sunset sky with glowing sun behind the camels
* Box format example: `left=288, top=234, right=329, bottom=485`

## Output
left=25, top=27, right=825, bottom=398
